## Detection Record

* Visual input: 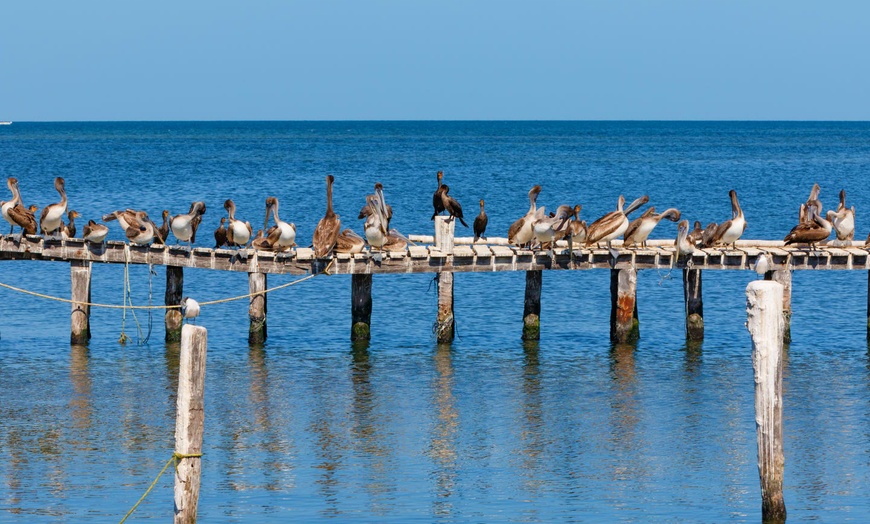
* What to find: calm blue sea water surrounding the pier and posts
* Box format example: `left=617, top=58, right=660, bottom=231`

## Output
left=0, top=122, right=870, bottom=522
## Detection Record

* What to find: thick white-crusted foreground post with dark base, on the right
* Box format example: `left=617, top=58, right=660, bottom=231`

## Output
left=746, top=280, right=786, bottom=522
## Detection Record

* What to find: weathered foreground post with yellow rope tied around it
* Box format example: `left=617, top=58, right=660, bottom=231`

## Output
left=175, top=324, right=208, bottom=524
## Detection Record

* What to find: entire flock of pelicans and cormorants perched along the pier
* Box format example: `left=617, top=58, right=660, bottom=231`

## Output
left=0, top=176, right=870, bottom=258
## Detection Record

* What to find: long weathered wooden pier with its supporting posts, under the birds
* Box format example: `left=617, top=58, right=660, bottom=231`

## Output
left=0, top=217, right=870, bottom=344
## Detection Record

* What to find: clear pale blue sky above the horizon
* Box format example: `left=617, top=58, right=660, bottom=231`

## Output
left=0, top=0, right=870, bottom=121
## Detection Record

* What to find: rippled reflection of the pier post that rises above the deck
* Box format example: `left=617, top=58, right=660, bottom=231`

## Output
left=429, top=344, right=459, bottom=516
